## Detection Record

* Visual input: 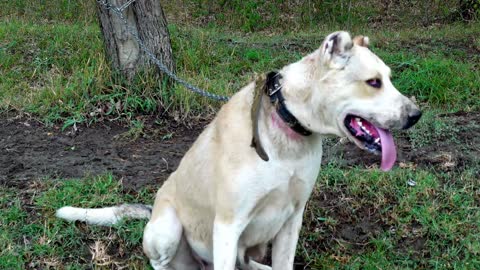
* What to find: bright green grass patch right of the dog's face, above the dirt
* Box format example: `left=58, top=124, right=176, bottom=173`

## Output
left=378, top=51, right=480, bottom=111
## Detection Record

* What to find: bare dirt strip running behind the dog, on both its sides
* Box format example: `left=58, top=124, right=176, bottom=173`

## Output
left=0, top=112, right=480, bottom=189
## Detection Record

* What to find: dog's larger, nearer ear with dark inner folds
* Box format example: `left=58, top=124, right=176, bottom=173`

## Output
left=321, top=31, right=353, bottom=68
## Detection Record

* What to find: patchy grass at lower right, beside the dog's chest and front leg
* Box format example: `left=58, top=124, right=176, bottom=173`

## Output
left=298, top=165, right=480, bottom=269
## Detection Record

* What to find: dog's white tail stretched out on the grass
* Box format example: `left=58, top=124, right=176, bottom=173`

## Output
left=56, top=204, right=152, bottom=226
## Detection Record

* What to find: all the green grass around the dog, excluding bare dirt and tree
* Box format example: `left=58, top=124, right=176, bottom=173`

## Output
left=0, top=0, right=480, bottom=269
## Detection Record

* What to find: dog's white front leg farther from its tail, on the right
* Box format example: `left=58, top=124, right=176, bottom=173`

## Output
left=272, top=208, right=304, bottom=270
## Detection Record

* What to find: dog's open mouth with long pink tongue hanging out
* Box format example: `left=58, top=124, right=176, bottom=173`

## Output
left=344, top=114, right=397, bottom=171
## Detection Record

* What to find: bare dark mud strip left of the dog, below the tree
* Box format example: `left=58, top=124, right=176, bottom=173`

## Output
left=0, top=116, right=204, bottom=189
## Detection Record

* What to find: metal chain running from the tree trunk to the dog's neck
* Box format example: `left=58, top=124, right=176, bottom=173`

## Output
left=97, top=0, right=230, bottom=101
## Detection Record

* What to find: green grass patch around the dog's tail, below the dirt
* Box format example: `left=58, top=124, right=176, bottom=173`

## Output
left=0, top=175, right=154, bottom=269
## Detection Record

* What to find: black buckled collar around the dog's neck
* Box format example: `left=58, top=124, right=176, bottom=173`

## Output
left=265, top=71, right=312, bottom=136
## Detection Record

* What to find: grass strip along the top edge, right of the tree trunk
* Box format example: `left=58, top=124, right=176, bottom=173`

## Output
left=162, top=0, right=472, bottom=32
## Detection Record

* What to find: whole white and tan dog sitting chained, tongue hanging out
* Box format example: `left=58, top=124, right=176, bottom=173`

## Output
left=57, top=32, right=421, bottom=270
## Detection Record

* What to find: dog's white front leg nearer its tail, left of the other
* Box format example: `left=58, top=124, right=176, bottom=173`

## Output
left=213, top=217, right=246, bottom=270
